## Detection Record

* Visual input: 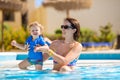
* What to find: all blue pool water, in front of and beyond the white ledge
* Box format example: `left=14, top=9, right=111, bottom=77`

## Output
left=0, top=52, right=120, bottom=80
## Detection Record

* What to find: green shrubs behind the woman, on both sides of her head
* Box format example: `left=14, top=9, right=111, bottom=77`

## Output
left=47, top=23, right=116, bottom=42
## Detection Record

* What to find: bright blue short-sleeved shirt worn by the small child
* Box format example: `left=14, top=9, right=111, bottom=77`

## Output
left=25, top=36, right=46, bottom=60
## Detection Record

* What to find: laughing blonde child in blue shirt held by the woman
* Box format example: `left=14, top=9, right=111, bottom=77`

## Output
left=11, top=22, right=48, bottom=70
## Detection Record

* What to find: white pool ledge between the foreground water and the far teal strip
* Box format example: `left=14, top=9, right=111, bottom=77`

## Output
left=0, top=60, right=120, bottom=70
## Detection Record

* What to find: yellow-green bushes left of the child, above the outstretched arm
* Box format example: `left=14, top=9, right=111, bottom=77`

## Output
left=0, top=24, right=28, bottom=51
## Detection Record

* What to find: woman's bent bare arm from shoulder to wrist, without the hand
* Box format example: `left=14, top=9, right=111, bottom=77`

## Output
left=49, top=43, right=82, bottom=65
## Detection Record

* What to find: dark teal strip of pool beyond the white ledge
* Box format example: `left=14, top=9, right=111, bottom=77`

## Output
left=15, top=53, right=120, bottom=60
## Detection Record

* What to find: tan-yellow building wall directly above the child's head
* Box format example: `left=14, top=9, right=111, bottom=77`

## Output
left=26, top=0, right=47, bottom=33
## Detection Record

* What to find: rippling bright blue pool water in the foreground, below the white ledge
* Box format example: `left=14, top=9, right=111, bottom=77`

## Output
left=0, top=65, right=120, bottom=80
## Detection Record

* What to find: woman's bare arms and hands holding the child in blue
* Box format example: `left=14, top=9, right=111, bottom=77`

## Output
left=35, top=42, right=82, bottom=65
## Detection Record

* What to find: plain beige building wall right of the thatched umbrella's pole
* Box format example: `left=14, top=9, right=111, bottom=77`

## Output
left=71, top=0, right=120, bottom=34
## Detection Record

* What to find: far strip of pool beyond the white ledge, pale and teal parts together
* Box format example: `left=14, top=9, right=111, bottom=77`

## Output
left=0, top=51, right=120, bottom=61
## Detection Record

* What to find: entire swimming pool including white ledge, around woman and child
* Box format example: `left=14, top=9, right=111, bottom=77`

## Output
left=0, top=51, right=120, bottom=80
